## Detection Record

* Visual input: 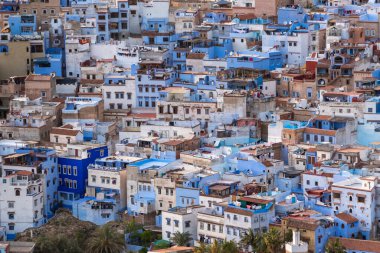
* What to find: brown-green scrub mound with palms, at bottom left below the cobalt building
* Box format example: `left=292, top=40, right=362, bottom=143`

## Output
left=16, top=209, right=147, bottom=253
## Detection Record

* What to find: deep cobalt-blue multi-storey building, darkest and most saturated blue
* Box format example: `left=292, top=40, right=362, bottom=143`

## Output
left=58, top=145, right=108, bottom=208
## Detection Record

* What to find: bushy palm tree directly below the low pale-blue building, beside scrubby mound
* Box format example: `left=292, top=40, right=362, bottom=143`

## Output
left=86, top=225, right=125, bottom=253
